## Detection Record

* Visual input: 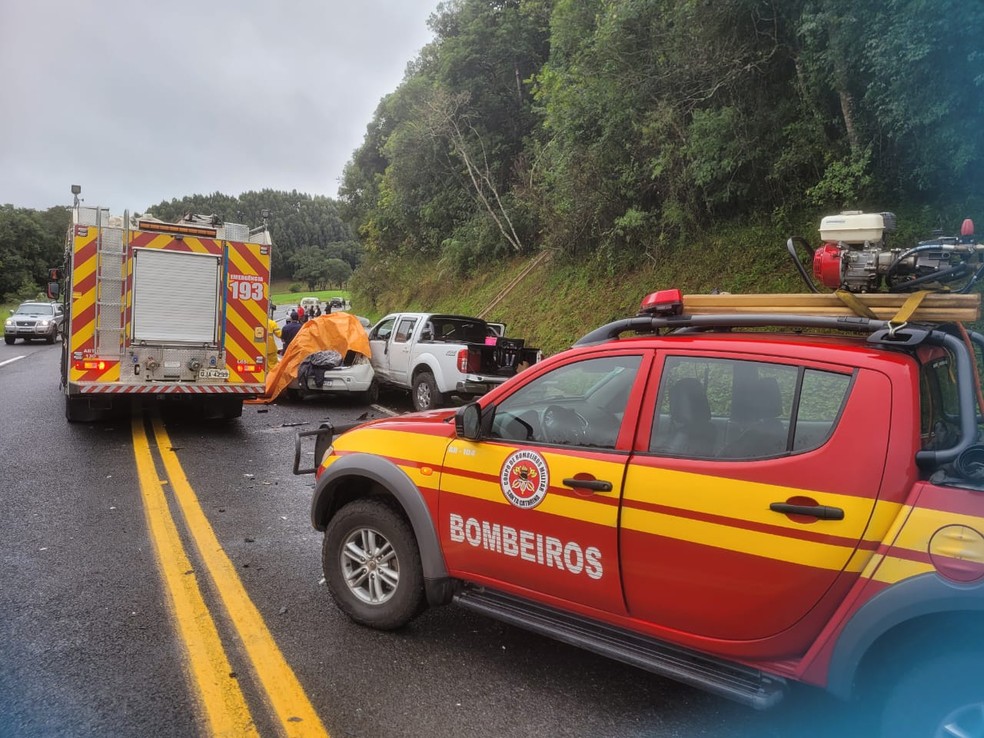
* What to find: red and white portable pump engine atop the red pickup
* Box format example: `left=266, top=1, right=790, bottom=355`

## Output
left=786, top=211, right=984, bottom=292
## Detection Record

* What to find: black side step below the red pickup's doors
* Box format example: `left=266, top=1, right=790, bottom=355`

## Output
left=454, top=589, right=786, bottom=710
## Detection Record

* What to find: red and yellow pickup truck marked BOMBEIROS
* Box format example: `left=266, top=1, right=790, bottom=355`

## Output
left=294, top=290, right=984, bottom=736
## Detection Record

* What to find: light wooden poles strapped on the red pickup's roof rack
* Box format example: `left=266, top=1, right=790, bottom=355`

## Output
left=683, top=292, right=981, bottom=323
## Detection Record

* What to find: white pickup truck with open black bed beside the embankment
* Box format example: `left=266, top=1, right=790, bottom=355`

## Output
left=369, top=313, right=541, bottom=410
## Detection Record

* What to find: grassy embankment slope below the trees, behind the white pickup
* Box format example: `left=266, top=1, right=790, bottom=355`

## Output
left=352, top=216, right=812, bottom=355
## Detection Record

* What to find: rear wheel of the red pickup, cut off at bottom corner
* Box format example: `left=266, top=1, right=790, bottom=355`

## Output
left=880, top=651, right=984, bottom=738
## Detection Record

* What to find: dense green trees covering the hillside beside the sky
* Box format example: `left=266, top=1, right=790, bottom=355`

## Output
left=340, top=0, right=984, bottom=295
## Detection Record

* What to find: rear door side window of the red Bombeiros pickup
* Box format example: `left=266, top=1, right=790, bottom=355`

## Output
left=649, top=356, right=851, bottom=461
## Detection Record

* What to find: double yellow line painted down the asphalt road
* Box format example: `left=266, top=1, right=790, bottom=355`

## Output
left=132, top=412, right=328, bottom=738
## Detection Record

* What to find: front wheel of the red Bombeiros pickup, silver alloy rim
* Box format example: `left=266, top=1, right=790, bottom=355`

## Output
left=321, top=500, right=426, bottom=630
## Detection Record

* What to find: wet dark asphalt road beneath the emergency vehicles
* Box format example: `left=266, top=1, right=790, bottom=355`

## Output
left=0, top=342, right=876, bottom=738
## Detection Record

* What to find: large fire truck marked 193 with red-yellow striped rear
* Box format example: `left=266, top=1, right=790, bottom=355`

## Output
left=56, top=200, right=272, bottom=423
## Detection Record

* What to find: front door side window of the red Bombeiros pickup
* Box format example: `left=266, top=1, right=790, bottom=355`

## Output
left=491, top=355, right=642, bottom=448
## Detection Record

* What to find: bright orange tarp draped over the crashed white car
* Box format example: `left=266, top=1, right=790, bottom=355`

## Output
left=247, top=313, right=371, bottom=403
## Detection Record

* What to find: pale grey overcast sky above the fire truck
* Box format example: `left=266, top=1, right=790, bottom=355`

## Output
left=0, top=0, right=439, bottom=214
